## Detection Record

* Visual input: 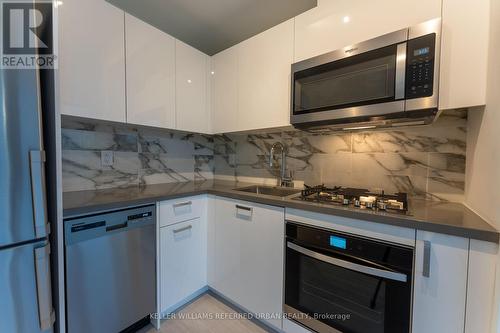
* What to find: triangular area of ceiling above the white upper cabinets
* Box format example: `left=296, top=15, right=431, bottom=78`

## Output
left=107, top=0, right=317, bottom=55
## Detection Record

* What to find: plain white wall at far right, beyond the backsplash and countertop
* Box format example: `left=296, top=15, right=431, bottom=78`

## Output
left=465, top=0, right=500, bottom=332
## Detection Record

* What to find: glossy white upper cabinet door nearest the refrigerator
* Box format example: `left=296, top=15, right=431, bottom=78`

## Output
left=58, top=0, right=126, bottom=122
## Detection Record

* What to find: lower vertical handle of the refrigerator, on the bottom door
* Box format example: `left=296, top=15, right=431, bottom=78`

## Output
left=35, top=243, right=56, bottom=331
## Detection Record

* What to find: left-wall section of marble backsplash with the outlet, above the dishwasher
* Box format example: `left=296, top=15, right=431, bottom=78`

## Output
left=62, top=116, right=214, bottom=192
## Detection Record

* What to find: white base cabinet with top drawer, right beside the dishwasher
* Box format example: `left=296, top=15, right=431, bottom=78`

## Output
left=157, top=195, right=208, bottom=314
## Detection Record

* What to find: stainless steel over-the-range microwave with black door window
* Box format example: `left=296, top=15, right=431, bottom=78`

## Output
left=290, top=18, right=441, bottom=127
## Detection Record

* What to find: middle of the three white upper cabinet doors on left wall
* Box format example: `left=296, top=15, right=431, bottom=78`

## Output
left=125, top=14, right=175, bottom=128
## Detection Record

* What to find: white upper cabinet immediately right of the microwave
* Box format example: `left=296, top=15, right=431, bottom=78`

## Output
left=439, top=0, right=490, bottom=110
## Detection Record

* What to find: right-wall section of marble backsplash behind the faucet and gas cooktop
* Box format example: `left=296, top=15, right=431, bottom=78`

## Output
left=214, top=109, right=467, bottom=202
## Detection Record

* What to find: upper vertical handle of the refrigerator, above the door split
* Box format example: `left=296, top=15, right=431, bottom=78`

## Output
left=30, top=150, right=50, bottom=238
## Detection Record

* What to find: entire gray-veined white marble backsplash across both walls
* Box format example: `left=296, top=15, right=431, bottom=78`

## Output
left=62, top=109, right=467, bottom=201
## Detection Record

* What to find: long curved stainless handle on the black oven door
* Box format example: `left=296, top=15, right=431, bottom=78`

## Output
left=287, top=242, right=408, bottom=282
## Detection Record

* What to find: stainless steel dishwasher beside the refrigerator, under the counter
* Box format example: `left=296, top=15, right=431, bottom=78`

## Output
left=65, top=205, right=156, bottom=333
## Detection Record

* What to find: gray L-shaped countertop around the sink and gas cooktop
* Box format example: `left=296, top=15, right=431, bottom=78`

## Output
left=63, top=180, right=499, bottom=243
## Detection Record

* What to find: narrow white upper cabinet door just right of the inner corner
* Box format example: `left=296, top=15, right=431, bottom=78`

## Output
left=211, top=45, right=238, bottom=133
